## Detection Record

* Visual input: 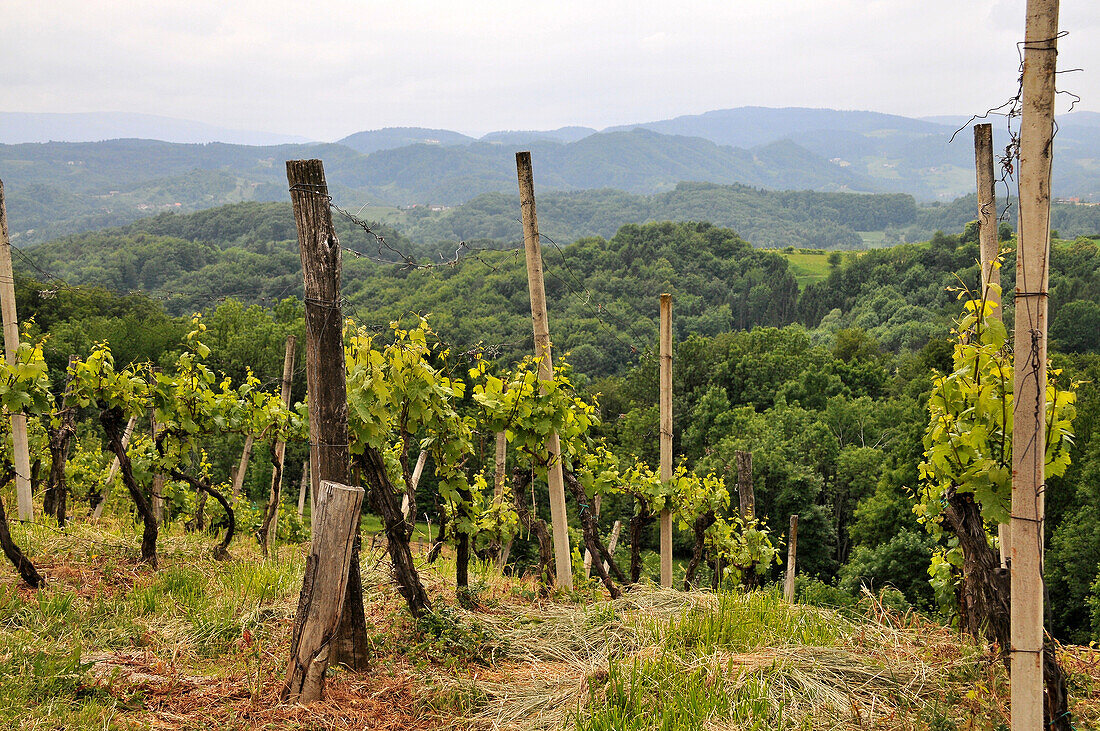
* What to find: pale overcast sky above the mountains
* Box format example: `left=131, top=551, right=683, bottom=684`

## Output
left=0, top=0, right=1100, bottom=140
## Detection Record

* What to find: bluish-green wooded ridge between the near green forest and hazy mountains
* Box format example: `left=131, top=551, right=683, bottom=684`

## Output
left=407, top=182, right=1100, bottom=250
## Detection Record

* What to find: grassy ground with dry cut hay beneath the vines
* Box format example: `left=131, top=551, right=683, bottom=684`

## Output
left=8, top=519, right=1100, bottom=731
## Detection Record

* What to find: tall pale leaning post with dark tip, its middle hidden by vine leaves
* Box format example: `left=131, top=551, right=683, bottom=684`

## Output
left=516, top=152, right=573, bottom=590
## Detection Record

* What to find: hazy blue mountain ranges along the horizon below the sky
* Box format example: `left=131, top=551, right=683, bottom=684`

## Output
left=0, top=108, right=1100, bottom=243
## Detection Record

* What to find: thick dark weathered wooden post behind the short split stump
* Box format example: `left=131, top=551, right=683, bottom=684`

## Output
left=286, top=159, right=369, bottom=669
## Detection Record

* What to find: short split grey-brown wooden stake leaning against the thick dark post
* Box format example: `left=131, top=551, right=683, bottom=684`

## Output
left=282, top=479, right=363, bottom=704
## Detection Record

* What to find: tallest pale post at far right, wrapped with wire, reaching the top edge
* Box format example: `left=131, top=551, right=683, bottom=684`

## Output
left=1011, top=0, right=1058, bottom=731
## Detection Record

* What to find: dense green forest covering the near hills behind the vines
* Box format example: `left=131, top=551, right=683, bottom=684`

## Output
left=17, top=196, right=1100, bottom=641
